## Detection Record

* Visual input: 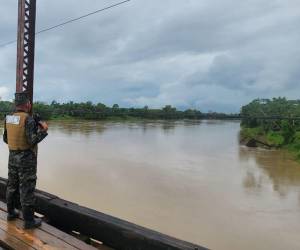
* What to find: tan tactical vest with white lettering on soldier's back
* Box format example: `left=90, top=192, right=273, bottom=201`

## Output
left=5, top=112, right=32, bottom=150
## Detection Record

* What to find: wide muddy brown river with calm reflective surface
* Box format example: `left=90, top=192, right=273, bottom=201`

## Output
left=0, top=121, right=300, bottom=250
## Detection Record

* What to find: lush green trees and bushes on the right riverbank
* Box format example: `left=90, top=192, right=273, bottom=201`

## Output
left=240, top=98, right=300, bottom=160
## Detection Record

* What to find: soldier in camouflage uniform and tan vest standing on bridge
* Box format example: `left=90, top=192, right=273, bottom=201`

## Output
left=3, top=93, right=48, bottom=229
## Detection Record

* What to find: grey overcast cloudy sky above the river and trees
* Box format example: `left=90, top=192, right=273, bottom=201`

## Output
left=0, top=0, right=300, bottom=112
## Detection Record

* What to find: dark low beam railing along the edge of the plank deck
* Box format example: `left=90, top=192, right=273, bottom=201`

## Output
left=0, top=178, right=208, bottom=250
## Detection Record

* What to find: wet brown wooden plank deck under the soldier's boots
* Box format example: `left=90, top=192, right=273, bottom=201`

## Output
left=0, top=202, right=107, bottom=250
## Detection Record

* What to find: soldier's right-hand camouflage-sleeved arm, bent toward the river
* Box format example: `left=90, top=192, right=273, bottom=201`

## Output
left=25, top=117, right=48, bottom=146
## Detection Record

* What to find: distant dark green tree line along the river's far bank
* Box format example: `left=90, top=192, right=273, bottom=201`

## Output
left=0, top=101, right=239, bottom=120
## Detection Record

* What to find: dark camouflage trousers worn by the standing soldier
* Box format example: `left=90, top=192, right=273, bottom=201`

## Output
left=6, top=150, right=37, bottom=210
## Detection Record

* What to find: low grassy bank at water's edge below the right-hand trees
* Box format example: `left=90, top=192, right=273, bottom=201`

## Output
left=240, top=127, right=300, bottom=162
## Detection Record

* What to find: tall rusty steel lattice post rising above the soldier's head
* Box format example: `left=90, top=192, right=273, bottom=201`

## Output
left=16, top=0, right=36, bottom=110
